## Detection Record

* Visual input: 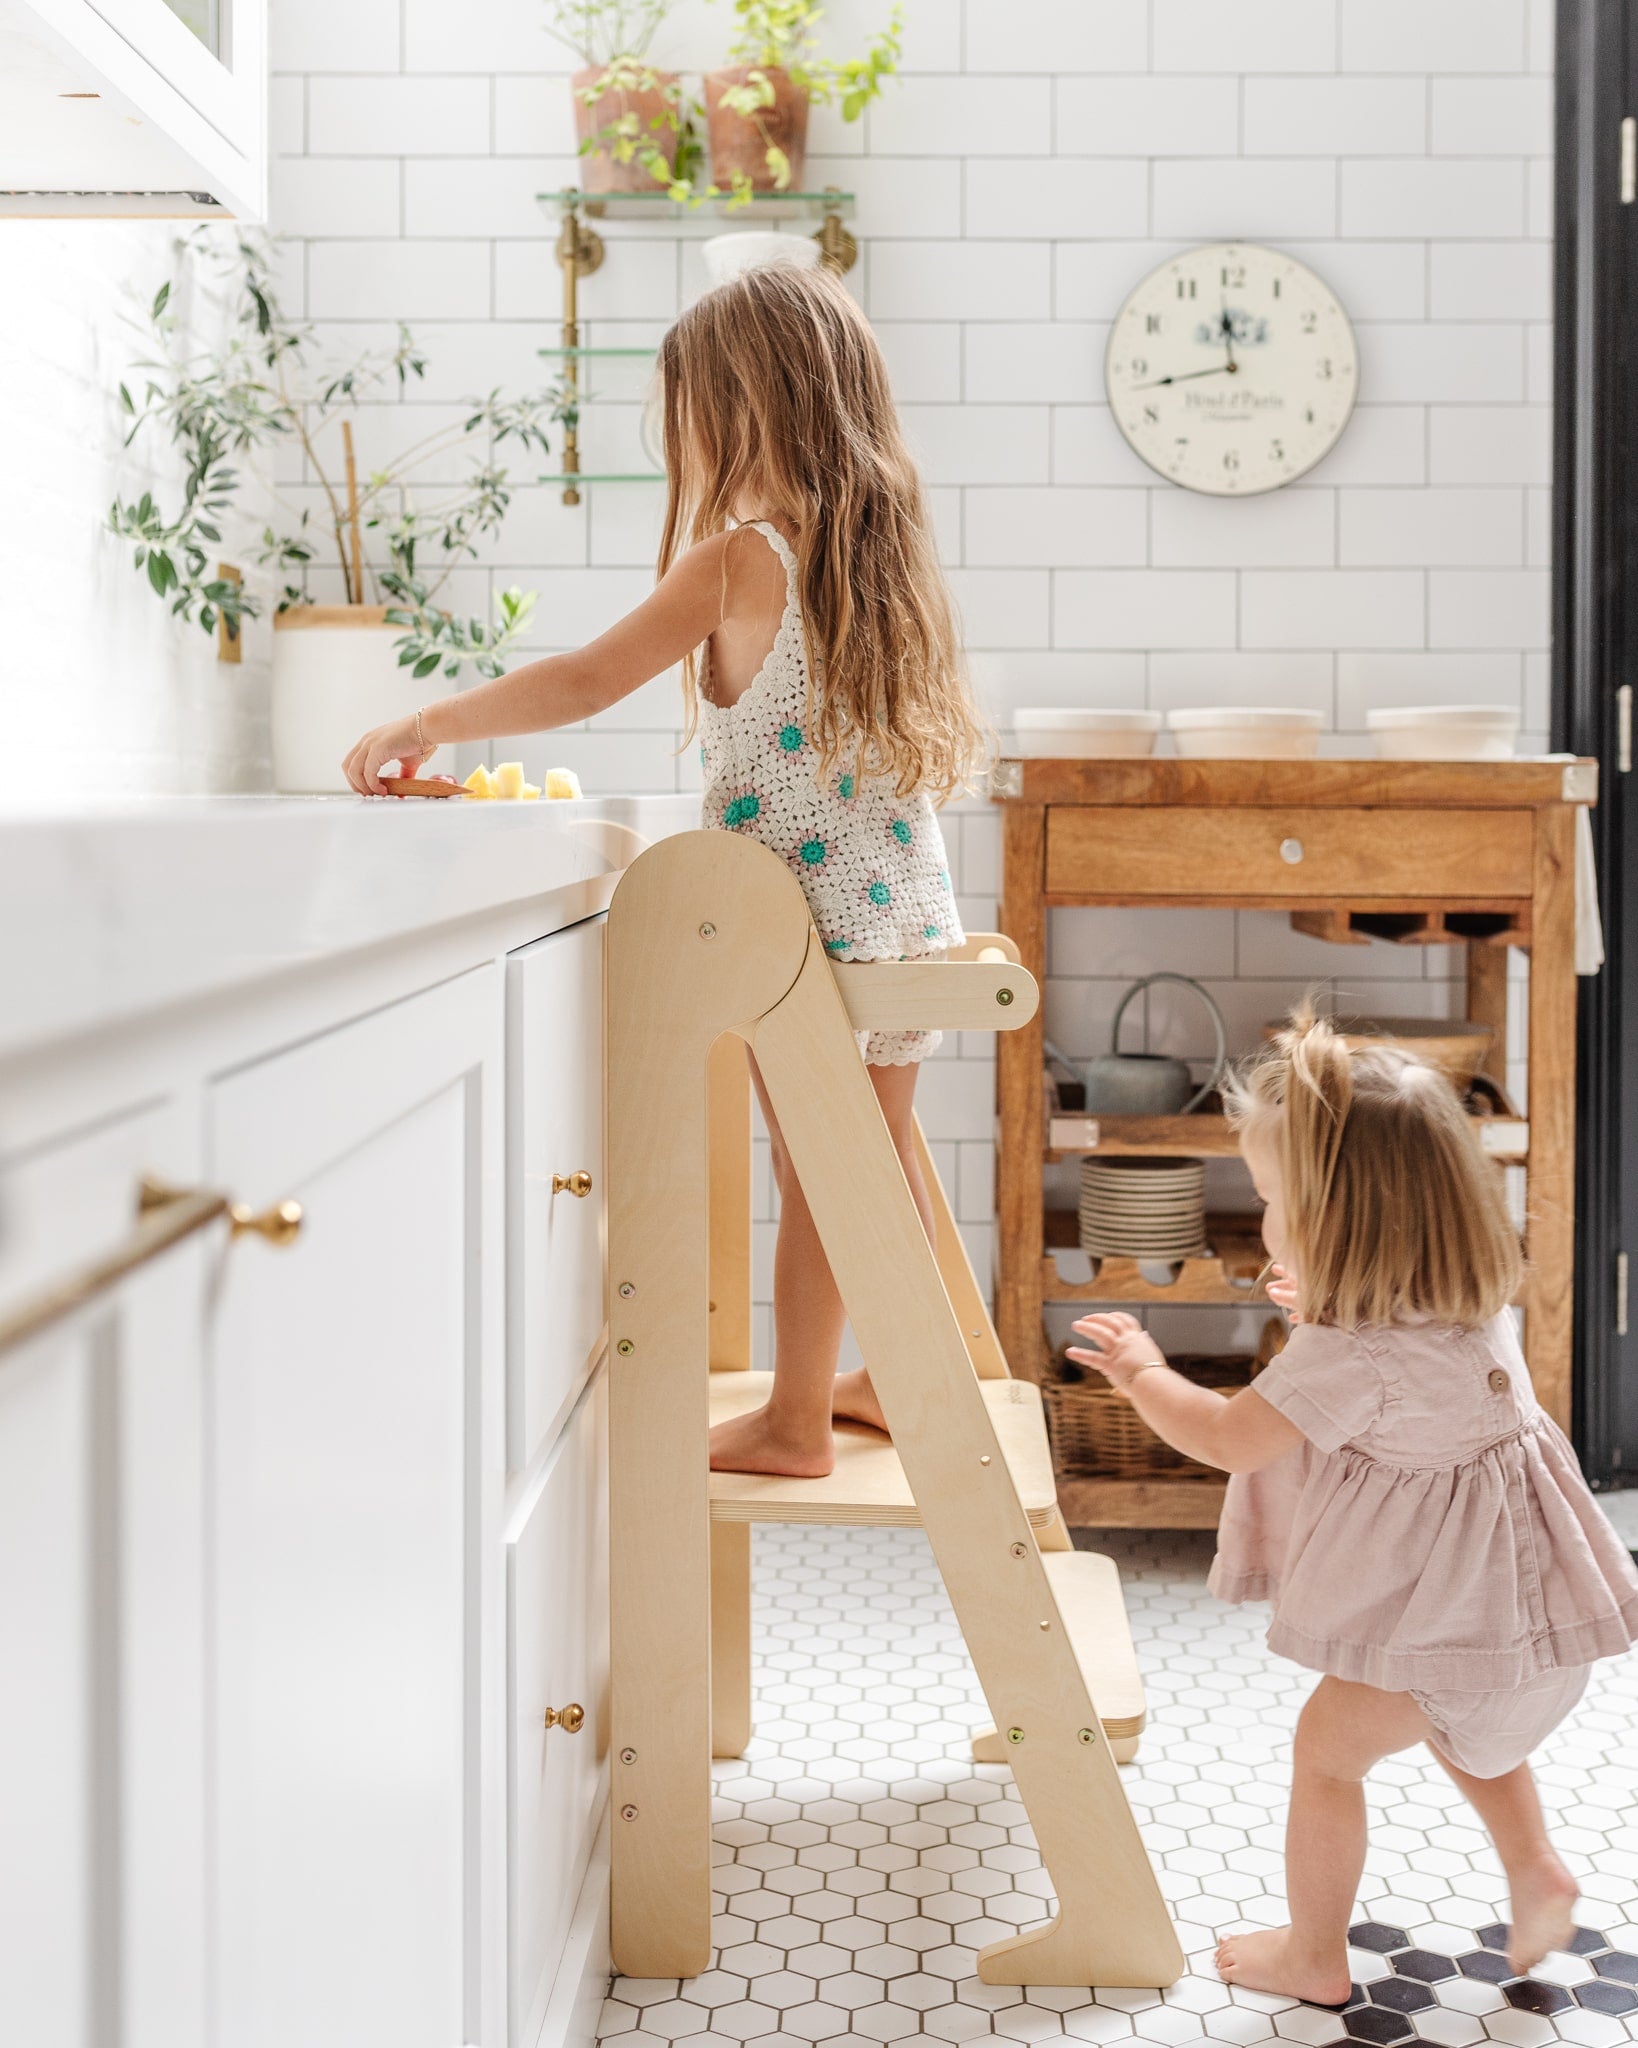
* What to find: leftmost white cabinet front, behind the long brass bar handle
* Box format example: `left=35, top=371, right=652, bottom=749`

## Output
left=0, top=1104, right=210, bottom=2048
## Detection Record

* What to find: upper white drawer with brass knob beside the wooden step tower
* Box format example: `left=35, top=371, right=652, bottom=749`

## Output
left=506, top=918, right=604, bottom=1473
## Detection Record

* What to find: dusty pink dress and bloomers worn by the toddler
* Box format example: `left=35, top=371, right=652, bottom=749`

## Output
left=1210, top=1315, right=1638, bottom=1778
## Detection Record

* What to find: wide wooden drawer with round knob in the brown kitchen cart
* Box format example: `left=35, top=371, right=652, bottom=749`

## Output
left=1046, top=805, right=1534, bottom=899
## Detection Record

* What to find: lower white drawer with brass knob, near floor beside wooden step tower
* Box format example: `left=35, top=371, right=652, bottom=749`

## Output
left=506, top=1376, right=608, bottom=2048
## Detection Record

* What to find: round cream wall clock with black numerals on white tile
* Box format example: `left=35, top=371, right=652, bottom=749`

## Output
left=1104, top=242, right=1360, bottom=498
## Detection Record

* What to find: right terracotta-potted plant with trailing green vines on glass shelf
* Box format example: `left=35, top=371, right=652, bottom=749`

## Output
left=704, top=0, right=903, bottom=199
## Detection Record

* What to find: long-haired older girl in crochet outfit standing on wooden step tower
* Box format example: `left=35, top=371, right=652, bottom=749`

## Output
left=346, top=268, right=983, bottom=1477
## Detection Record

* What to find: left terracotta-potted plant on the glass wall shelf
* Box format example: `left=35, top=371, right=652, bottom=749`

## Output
left=547, top=0, right=690, bottom=197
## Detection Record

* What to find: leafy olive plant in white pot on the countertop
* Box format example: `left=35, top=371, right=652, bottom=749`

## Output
left=109, top=238, right=573, bottom=791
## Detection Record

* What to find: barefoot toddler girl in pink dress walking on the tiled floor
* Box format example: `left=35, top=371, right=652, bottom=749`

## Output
left=1069, top=1014, right=1638, bottom=2003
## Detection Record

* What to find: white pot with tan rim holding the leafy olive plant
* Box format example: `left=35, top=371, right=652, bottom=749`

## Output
left=272, top=604, right=426, bottom=795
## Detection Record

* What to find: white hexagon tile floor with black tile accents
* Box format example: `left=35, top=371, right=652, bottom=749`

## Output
left=602, top=1526, right=1638, bottom=2048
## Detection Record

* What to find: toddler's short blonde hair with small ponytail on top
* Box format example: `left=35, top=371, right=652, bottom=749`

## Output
left=1226, top=1004, right=1523, bottom=1329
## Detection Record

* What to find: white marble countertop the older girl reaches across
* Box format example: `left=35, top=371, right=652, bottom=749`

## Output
left=0, top=797, right=698, bottom=1057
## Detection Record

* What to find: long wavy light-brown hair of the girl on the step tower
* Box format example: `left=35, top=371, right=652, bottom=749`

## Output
left=659, top=266, right=989, bottom=797
